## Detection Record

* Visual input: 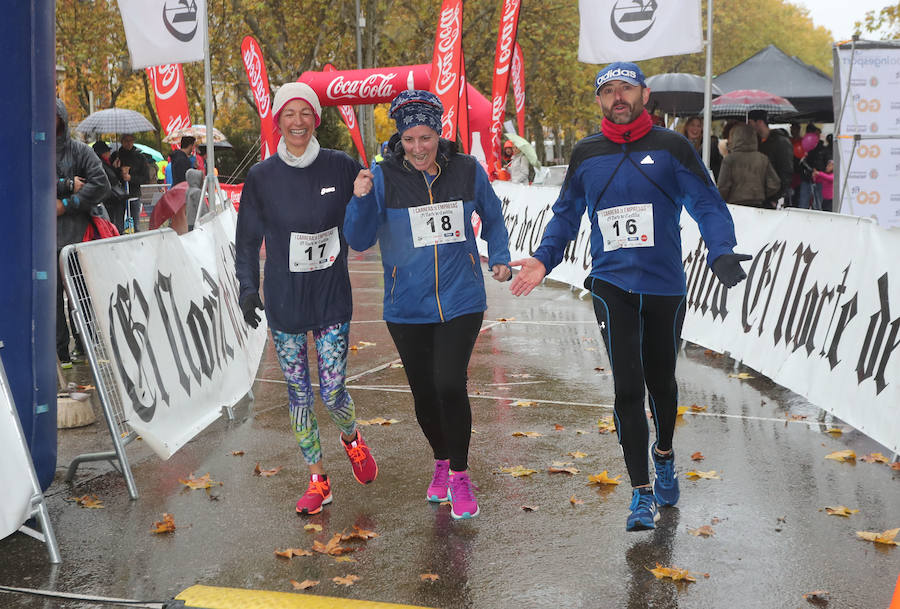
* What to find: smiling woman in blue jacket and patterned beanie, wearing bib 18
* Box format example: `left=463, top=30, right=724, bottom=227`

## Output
left=344, top=90, right=511, bottom=518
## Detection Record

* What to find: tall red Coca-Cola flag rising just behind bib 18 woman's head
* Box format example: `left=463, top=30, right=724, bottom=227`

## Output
left=431, top=0, right=462, bottom=141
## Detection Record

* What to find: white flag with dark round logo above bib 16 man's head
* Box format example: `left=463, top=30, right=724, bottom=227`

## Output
left=578, top=0, right=703, bottom=63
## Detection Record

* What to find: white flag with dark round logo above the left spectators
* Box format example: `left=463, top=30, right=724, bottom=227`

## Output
left=118, top=0, right=206, bottom=70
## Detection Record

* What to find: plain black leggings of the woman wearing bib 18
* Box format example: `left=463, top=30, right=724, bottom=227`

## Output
left=387, top=313, right=484, bottom=472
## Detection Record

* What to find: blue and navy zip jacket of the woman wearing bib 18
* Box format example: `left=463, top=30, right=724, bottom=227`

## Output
left=344, top=140, right=509, bottom=324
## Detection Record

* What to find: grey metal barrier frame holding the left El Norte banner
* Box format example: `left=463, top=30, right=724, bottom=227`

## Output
left=59, top=234, right=141, bottom=499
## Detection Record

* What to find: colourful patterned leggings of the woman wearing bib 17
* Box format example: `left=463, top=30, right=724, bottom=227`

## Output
left=272, top=322, right=356, bottom=465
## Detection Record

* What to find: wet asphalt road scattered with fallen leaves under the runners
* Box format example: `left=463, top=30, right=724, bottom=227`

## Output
left=0, top=251, right=900, bottom=609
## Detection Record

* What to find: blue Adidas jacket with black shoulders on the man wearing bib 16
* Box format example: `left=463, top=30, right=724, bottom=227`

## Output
left=534, top=127, right=736, bottom=296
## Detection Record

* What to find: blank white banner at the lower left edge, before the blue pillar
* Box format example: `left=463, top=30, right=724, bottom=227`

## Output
left=0, top=352, right=36, bottom=539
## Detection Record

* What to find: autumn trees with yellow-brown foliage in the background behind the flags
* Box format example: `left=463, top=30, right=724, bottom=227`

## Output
left=56, top=0, right=844, bottom=174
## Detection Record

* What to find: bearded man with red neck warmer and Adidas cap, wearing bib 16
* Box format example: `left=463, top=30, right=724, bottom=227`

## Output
left=510, top=62, right=750, bottom=531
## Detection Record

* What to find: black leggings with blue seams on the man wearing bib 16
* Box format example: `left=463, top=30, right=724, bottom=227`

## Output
left=585, top=277, right=684, bottom=486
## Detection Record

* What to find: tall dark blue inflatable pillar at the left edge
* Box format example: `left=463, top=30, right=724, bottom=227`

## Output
left=0, top=0, right=59, bottom=490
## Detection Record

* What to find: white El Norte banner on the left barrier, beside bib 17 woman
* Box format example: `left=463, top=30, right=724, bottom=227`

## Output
left=76, top=207, right=266, bottom=459
